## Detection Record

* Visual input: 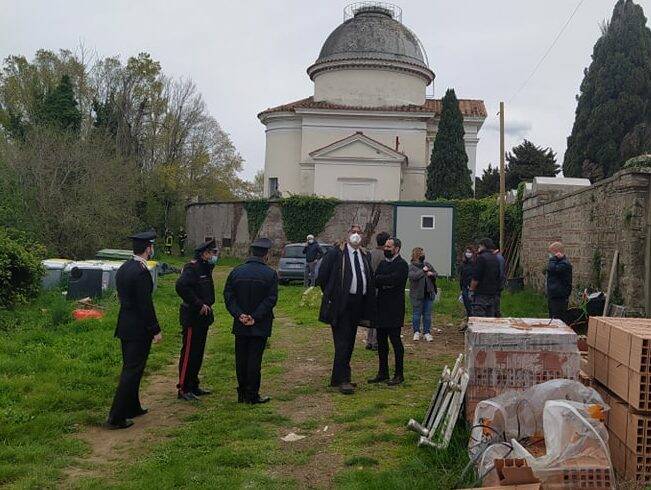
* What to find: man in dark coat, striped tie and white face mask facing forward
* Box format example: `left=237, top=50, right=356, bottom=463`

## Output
left=317, top=225, right=375, bottom=395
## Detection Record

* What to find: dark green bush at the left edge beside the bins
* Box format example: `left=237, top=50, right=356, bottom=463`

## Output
left=0, top=229, right=44, bottom=308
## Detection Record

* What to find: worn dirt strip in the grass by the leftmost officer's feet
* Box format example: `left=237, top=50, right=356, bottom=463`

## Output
left=62, top=363, right=196, bottom=487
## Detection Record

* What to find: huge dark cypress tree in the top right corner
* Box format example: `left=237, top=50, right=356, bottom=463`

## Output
left=563, top=0, right=651, bottom=178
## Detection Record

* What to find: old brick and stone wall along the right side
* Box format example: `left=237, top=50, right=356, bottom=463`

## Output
left=522, top=169, right=651, bottom=313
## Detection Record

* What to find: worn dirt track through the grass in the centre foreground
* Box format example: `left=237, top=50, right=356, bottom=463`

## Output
left=263, top=316, right=463, bottom=488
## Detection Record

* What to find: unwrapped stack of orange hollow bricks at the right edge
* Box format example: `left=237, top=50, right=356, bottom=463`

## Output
left=586, top=317, right=651, bottom=484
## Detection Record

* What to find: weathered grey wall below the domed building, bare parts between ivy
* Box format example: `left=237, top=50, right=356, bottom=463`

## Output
left=186, top=202, right=394, bottom=259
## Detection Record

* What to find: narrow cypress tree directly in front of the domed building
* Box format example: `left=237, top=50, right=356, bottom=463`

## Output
left=425, top=89, right=472, bottom=200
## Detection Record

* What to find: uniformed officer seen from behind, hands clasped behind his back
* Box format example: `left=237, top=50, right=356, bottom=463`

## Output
left=224, top=238, right=278, bottom=404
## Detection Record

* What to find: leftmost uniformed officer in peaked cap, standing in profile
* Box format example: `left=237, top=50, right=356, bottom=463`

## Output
left=106, top=231, right=162, bottom=429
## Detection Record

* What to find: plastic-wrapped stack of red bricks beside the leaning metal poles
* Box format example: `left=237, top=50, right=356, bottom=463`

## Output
left=466, top=317, right=581, bottom=422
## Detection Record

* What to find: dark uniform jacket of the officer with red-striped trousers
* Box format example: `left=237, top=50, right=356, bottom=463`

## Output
left=176, top=258, right=215, bottom=327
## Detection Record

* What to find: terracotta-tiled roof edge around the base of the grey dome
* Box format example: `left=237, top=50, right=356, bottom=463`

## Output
left=258, top=97, right=486, bottom=117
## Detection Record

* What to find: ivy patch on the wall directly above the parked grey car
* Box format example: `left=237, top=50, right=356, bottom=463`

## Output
left=280, top=196, right=339, bottom=242
